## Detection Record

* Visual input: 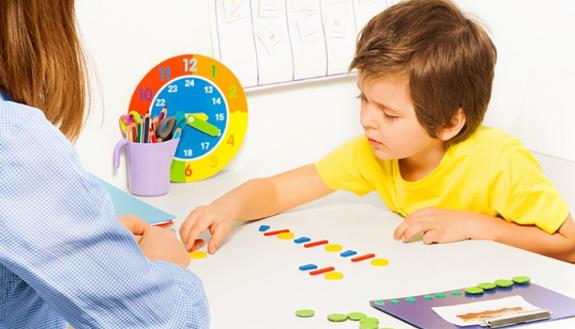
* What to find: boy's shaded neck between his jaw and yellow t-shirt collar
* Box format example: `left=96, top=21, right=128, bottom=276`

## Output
left=398, top=142, right=447, bottom=182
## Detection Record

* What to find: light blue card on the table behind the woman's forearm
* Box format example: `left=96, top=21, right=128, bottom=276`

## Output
left=92, top=175, right=175, bottom=225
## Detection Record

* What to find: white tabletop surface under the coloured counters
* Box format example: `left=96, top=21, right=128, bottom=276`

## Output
left=133, top=155, right=575, bottom=329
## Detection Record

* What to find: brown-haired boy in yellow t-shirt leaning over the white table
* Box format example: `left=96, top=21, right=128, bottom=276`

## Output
left=180, top=0, right=575, bottom=262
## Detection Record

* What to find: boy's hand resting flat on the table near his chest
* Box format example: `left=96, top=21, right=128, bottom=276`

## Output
left=393, top=208, right=480, bottom=244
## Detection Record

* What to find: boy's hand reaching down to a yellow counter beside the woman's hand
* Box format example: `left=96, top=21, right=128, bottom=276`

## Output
left=180, top=204, right=234, bottom=254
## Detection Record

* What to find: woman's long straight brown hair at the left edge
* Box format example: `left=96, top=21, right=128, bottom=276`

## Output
left=0, top=0, right=87, bottom=140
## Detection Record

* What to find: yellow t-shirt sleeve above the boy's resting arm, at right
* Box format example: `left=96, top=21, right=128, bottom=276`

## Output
left=492, top=143, right=569, bottom=234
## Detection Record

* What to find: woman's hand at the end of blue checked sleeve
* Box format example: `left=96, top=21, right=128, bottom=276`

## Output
left=119, top=215, right=190, bottom=268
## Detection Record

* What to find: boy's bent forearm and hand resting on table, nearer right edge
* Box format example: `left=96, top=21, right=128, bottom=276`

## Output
left=394, top=208, right=575, bottom=263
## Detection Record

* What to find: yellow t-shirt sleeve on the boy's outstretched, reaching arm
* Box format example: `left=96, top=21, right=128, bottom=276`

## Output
left=315, top=136, right=375, bottom=195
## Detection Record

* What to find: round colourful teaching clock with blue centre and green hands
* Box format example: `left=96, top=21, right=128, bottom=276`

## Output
left=129, top=54, right=248, bottom=182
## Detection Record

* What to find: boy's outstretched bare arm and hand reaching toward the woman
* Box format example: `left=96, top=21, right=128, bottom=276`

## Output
left=180, top=164, right=333, bottom=253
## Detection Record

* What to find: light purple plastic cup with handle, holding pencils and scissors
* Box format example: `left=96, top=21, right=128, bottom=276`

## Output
left=114, top=138, right=180, bottom=196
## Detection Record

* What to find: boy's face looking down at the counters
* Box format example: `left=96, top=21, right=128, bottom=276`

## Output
left=358, top=73, right=442, bottom=160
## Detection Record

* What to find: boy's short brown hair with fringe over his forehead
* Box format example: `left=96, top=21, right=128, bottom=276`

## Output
left=350, top=0, right=497, bottom=144
